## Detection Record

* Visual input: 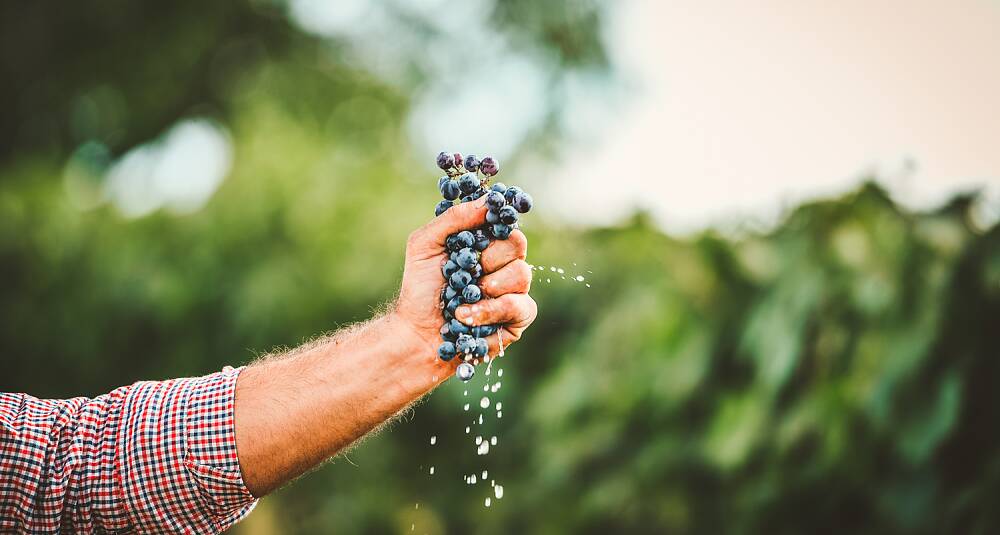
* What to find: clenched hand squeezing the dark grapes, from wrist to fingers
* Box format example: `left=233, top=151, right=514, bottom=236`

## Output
left=393, top=198, right=538, bottom=366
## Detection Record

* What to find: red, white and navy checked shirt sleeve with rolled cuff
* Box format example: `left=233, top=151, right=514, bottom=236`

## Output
left=0, top=367, right=257, bottom=533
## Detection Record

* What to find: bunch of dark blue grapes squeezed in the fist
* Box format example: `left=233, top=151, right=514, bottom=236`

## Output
left=434, top=152, right=532, bottom=381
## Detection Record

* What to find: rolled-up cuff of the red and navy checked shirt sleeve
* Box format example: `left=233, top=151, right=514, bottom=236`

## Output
left=116, top=367, right=257, bottom=533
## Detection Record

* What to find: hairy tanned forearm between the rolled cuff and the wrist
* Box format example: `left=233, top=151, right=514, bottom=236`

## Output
left=235, top=314, right=453, bottom=496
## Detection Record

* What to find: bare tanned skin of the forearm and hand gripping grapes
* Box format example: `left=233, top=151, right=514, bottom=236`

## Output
left=235, top=198, right=537, bottom=497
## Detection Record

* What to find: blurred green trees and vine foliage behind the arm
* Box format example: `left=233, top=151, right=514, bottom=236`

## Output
left=0, top=1, right=1000, bottom=533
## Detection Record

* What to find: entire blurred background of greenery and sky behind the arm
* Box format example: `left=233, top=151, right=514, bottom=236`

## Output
left=0, top=0, right=1000, bottom=534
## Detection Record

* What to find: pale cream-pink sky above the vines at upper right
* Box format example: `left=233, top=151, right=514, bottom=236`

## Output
left=536, top=0, right=1000, bottom=230
